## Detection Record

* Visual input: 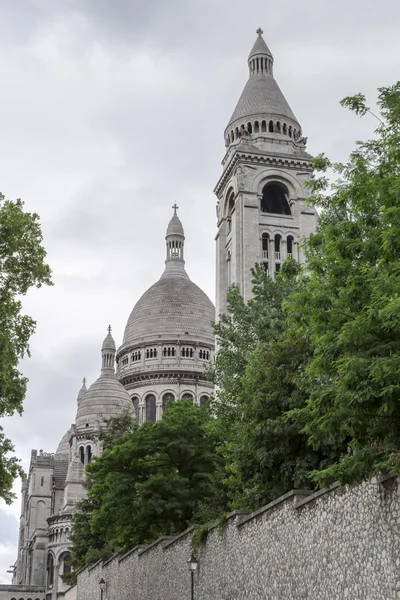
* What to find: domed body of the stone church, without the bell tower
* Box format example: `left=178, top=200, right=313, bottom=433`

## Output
left=0, top=212, right=215, bottom=600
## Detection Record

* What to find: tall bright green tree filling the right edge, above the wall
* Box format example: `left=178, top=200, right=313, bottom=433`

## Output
left=288, top=82, right=400, bottom=486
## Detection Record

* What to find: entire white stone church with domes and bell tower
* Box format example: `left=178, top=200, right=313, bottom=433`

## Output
left=0, top=29, right=317, bottom=600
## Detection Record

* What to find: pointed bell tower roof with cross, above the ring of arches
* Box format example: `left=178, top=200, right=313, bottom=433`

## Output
left=227, top=29, right=300, bottom=129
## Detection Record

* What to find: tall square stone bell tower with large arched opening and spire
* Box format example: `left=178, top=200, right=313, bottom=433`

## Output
left=214, top=29, right=318, bottom=317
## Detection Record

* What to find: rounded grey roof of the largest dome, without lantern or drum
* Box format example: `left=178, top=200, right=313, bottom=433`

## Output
left=123, top=271, right=215, bottom=346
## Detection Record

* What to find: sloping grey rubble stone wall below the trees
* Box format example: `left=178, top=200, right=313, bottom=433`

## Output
left=77, top=478, right=400, bottom=600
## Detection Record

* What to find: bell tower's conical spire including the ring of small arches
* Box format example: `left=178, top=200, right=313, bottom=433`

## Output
left=225, top=29, right=300, bottom=145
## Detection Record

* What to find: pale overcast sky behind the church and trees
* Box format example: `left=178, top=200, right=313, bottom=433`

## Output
left=0, top=0, right=400, bottom=583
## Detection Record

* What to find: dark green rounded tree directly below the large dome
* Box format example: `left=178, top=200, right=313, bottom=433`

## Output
left=68, top=400, right=225, bottom=568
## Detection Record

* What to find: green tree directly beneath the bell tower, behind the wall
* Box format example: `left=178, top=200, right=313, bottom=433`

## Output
left=212, top=259, right=331, bottom=508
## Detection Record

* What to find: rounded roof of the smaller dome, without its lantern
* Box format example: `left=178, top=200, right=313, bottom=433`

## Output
left=75, top=373, right=133, bottom=429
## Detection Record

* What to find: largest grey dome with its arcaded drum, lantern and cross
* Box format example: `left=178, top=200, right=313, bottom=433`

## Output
left=117, top=211, right=215, bottom=423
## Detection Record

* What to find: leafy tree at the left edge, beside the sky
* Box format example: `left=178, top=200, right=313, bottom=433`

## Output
left=0, top=194, right=51, bottom=503
